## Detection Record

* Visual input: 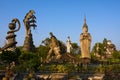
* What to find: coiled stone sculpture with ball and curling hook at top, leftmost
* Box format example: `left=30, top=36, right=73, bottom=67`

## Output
left=2, top=18, right=20, bottom=51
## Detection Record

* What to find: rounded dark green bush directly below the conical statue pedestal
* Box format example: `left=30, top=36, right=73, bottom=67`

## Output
left=19, top=52, right=40, bottom=71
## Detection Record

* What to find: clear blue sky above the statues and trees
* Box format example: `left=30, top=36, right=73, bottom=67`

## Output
left=0, top=0, right=120, bottom=50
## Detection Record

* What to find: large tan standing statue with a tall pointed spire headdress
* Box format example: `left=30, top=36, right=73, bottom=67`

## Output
left=80, top=18, right=92, bottom=59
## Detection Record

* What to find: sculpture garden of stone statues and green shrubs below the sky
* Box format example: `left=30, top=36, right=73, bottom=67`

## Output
left=0, top=10, right=120, bottom=80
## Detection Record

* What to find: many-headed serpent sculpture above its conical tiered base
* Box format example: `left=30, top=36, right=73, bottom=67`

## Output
left=23, top=10, right=36, bottom=36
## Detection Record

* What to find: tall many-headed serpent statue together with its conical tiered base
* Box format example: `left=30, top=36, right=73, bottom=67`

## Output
left=23, top=10, right=36, bottom=52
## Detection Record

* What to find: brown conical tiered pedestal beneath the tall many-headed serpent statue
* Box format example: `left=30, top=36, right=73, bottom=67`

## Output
left=23, top=33, right=35, bottom=52
